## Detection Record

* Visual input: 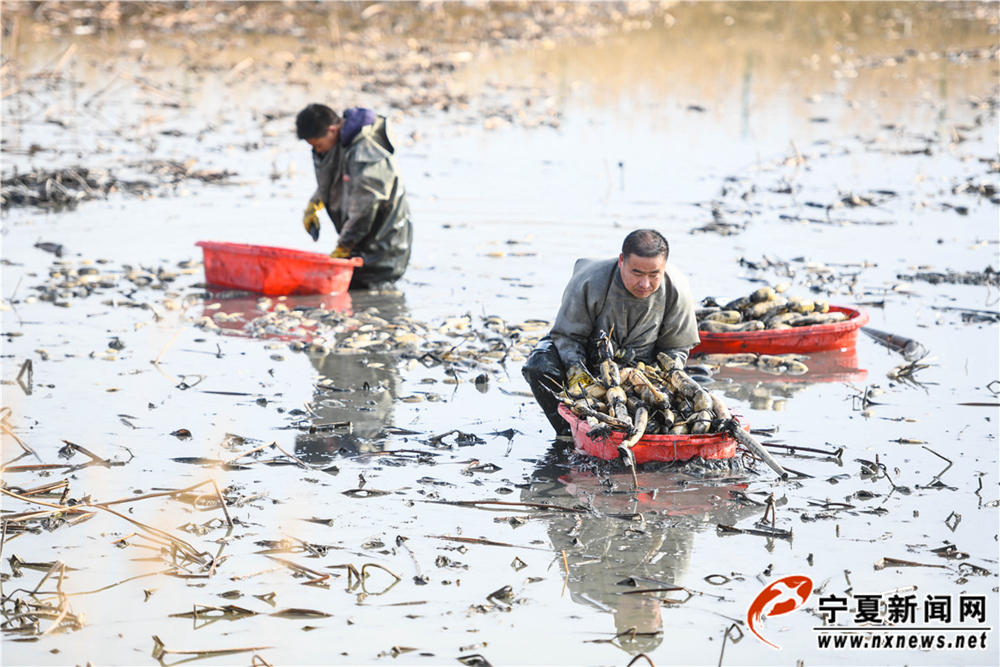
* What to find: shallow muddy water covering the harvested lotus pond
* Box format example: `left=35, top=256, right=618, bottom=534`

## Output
left=2, top=3, right=1000, bottom=665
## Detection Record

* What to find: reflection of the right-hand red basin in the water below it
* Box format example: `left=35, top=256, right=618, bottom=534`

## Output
left=707, top=347, right=868, bottom=412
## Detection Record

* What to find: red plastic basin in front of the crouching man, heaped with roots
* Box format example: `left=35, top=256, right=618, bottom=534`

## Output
left=559, top=405, right=747, bottom=463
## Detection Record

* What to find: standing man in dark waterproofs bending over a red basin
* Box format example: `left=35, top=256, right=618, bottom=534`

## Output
left=295, top=104, right=413, bottom=289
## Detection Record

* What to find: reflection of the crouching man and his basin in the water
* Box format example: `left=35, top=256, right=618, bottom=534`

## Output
left=521, top=460, right=761, bottom=654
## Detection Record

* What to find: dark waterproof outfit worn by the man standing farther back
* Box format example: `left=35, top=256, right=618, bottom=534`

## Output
left=312, top=116, right=413, bottom=287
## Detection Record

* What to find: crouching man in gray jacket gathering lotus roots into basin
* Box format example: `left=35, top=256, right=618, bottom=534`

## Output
left=521, top=229, right=700, bottom=435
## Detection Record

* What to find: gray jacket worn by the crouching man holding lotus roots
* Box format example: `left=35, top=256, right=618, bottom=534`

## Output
left=549, top=259, right=700, bottom=368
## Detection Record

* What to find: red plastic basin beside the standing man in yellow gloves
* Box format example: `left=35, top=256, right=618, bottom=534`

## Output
left=195, top=241, right=364, bottom=296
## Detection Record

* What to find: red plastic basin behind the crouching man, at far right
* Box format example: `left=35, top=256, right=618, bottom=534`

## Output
left=691, top=306, right=868, bottom=355
